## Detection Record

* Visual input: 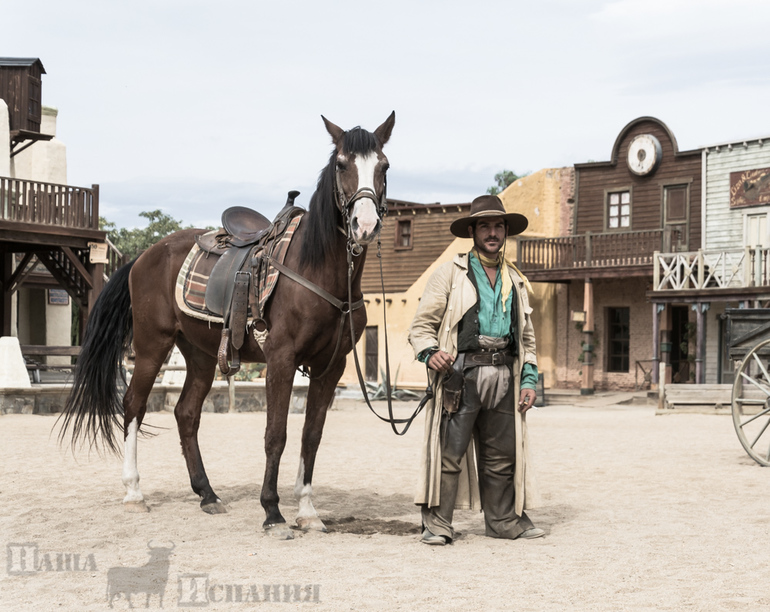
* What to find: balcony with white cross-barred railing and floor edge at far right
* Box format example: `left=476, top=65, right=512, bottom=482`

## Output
left=648, top=247, right=770, bottom=300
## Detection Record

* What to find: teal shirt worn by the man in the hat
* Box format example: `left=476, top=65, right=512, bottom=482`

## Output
left=419, top=253, right=537, bottom=389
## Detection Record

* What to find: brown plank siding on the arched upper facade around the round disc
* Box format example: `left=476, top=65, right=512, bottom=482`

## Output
left=574, top=117, right=701, bottom=247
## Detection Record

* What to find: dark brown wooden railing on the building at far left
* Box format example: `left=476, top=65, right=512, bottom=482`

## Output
left=0, top=176, right=99, bottom=230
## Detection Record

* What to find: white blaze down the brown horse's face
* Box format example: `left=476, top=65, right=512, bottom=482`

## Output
left=340, top=151, right=388, bottom=245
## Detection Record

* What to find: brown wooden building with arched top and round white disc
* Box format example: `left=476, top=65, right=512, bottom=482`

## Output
left=518, top=117, right=702, bottom=393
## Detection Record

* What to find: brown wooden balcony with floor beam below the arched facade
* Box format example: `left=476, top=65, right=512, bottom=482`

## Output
left=517, top=228, right=679, bottom=282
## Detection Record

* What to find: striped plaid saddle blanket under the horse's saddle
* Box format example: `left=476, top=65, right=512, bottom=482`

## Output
left=175, top=215, right=302, bottom=323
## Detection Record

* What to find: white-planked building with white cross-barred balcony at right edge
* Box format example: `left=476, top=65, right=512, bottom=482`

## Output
left=648, top=137, right=770, bottom=383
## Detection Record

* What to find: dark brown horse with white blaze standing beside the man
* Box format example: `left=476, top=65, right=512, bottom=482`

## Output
left=59, top=112, right=395, bottom=539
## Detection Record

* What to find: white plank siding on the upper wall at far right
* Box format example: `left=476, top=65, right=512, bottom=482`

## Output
left=704, top=139, right=770, bottom=251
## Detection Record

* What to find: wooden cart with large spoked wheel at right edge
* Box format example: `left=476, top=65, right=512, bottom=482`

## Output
left=725, top=308, right=770, bottom=466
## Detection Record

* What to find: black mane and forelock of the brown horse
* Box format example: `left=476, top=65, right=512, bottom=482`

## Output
left=300, top=127, right=379, bottom=268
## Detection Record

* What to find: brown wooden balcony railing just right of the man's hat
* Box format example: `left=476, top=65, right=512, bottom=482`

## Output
left=517, top=229, right=671, bottom=272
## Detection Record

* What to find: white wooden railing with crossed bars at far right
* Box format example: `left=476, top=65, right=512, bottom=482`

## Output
left=652, top=247, right=770, bottom=291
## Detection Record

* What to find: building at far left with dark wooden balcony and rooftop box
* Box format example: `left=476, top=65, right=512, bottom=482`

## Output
left=0, top=58, right=122, bottom=364
